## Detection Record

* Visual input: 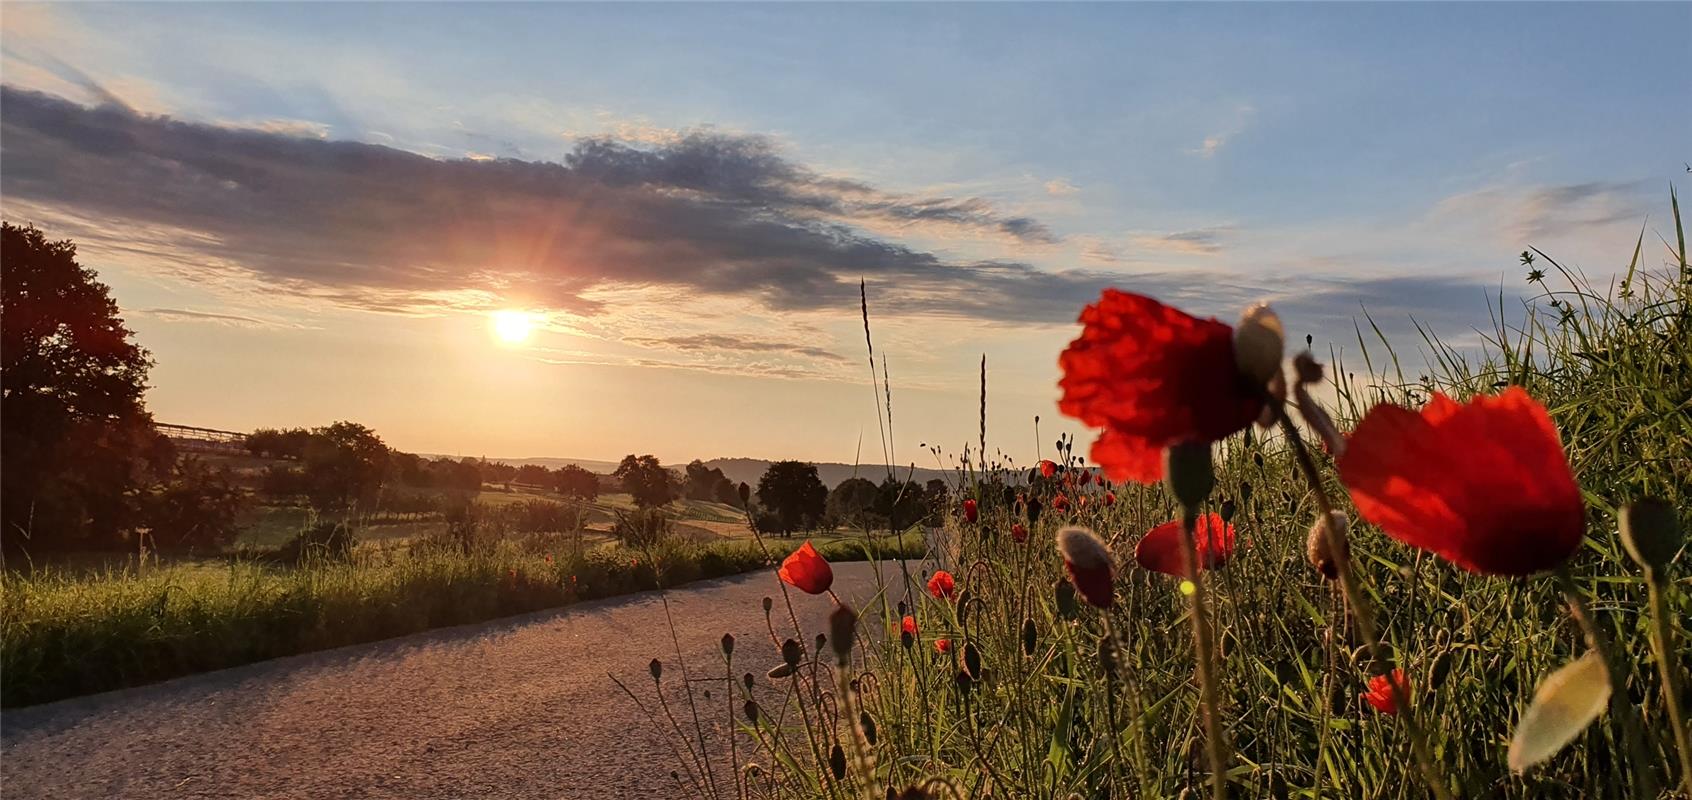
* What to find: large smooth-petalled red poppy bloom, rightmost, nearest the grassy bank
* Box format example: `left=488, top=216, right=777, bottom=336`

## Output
left=1338, top=386, right=1585, bottom=575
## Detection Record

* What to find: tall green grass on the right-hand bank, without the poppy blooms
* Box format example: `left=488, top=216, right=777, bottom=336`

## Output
left=629, top=196, right=1692, bottom=798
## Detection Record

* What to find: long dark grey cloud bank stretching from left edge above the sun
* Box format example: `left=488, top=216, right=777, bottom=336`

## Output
left=0, top=86, right=1082, bottom=321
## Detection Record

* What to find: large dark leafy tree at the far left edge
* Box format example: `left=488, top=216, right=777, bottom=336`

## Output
left=0, top=223, right=174, bottom=550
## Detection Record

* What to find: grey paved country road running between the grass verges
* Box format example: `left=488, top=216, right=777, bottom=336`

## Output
left=0, top=563, right=927, bottom=800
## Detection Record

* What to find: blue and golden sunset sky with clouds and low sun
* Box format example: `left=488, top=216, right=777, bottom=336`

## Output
left=0, top=2, right=1692, bottom=467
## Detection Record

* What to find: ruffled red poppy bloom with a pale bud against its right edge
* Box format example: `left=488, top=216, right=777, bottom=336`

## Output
left=1058, top=289, right=1262, bottom=482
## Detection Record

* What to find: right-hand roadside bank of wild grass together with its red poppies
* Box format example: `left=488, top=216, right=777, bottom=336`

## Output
left=631, top=194, right=1692, bottom=800
